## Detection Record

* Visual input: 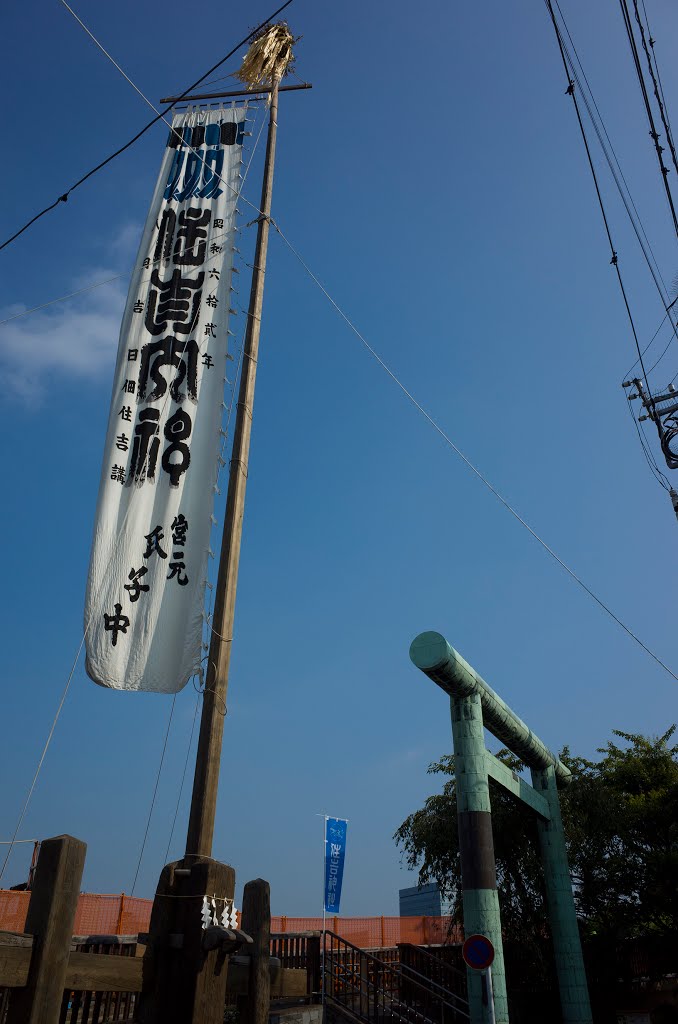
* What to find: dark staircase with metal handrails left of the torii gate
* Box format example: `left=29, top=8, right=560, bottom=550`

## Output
left=323, top=932, right=470, bottom=1024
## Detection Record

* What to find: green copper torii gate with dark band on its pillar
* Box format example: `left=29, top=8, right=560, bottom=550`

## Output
left=410, top=633, right=592, bottom=1024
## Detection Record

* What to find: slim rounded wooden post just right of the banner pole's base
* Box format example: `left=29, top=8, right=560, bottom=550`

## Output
left=238, top=879, right=270, bottom=1024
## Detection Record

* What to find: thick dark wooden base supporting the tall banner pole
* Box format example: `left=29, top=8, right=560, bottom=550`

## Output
left=135, top=857, right=236, bottom=1024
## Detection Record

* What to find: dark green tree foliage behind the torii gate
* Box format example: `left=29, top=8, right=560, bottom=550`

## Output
left=393, top=726, right=678, bottom=950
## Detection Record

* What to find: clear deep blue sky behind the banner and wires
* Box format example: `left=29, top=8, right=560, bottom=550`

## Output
left=0, top=0, right=678, bottom=915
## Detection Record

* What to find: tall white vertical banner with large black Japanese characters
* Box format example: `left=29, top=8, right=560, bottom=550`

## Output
left=85, top=108, right=245, bottom=693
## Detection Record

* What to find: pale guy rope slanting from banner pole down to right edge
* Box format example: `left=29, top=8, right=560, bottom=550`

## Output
left=270, top=218, right=678, bottom=683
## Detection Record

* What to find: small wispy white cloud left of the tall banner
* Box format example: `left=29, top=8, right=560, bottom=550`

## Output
left=0, top=225, right=138, bottom=403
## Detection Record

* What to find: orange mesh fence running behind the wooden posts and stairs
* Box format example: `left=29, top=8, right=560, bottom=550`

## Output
left=0, top=889, right=462, bottom=949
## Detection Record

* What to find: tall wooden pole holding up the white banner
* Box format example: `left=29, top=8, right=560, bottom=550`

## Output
left=186, top=81, right=279, bottom=857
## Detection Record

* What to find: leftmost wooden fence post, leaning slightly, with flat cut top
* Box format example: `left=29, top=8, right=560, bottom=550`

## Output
left=7, top=836, right=87, bottom=1024
